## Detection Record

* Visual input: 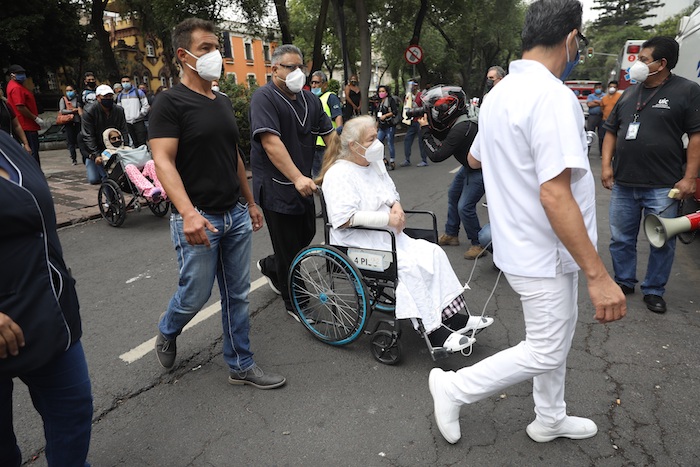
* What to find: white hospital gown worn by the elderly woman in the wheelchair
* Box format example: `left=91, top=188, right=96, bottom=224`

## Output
left=322, top=160, right=464, bottom=332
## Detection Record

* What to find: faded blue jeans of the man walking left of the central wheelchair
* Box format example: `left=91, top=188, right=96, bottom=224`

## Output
left=158, top=203, right=255, bottom=371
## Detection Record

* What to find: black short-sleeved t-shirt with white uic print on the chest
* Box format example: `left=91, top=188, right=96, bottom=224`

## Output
left=604, top=75, right=700, bottom=188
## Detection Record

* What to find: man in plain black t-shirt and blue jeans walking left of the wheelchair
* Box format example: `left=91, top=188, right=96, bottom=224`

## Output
left=150, top=18, right=286, bottom=389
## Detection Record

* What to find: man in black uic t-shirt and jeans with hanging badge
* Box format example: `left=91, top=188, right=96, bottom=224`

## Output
left=601, top=37, right=700, bottom=313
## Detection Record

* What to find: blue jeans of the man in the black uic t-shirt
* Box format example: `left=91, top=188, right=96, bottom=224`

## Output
left=610, top=184, right=678, bottom=296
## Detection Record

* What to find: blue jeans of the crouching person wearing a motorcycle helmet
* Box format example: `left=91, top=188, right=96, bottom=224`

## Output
left=445, top=167, right=484, bottom=245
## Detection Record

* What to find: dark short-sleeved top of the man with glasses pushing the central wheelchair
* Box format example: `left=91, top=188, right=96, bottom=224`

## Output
left=250, top=82, right=333, bottom=214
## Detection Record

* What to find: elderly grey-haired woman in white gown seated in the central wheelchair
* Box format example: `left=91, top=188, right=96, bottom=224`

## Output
left=316, top=116, right=493, bottom=352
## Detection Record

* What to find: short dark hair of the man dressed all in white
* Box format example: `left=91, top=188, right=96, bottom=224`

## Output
left=521, top=0, right=583, bottom=52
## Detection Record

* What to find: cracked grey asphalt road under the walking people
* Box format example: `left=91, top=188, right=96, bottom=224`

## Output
left=10, top=141, right=700, bottom=466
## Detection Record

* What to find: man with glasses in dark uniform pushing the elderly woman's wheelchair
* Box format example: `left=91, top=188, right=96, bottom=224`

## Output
left=250, top=44, right=338, bottom=320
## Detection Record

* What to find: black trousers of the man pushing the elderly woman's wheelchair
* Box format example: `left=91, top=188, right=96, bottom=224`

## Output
left=260, top=204, right=316, bottom=310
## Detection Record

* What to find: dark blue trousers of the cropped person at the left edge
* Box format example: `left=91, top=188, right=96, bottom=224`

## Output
left=0, top=341, right=92, bottom=466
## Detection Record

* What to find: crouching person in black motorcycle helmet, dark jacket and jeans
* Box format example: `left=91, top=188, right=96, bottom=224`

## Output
left=412, top=85, right=486, bottom=260
